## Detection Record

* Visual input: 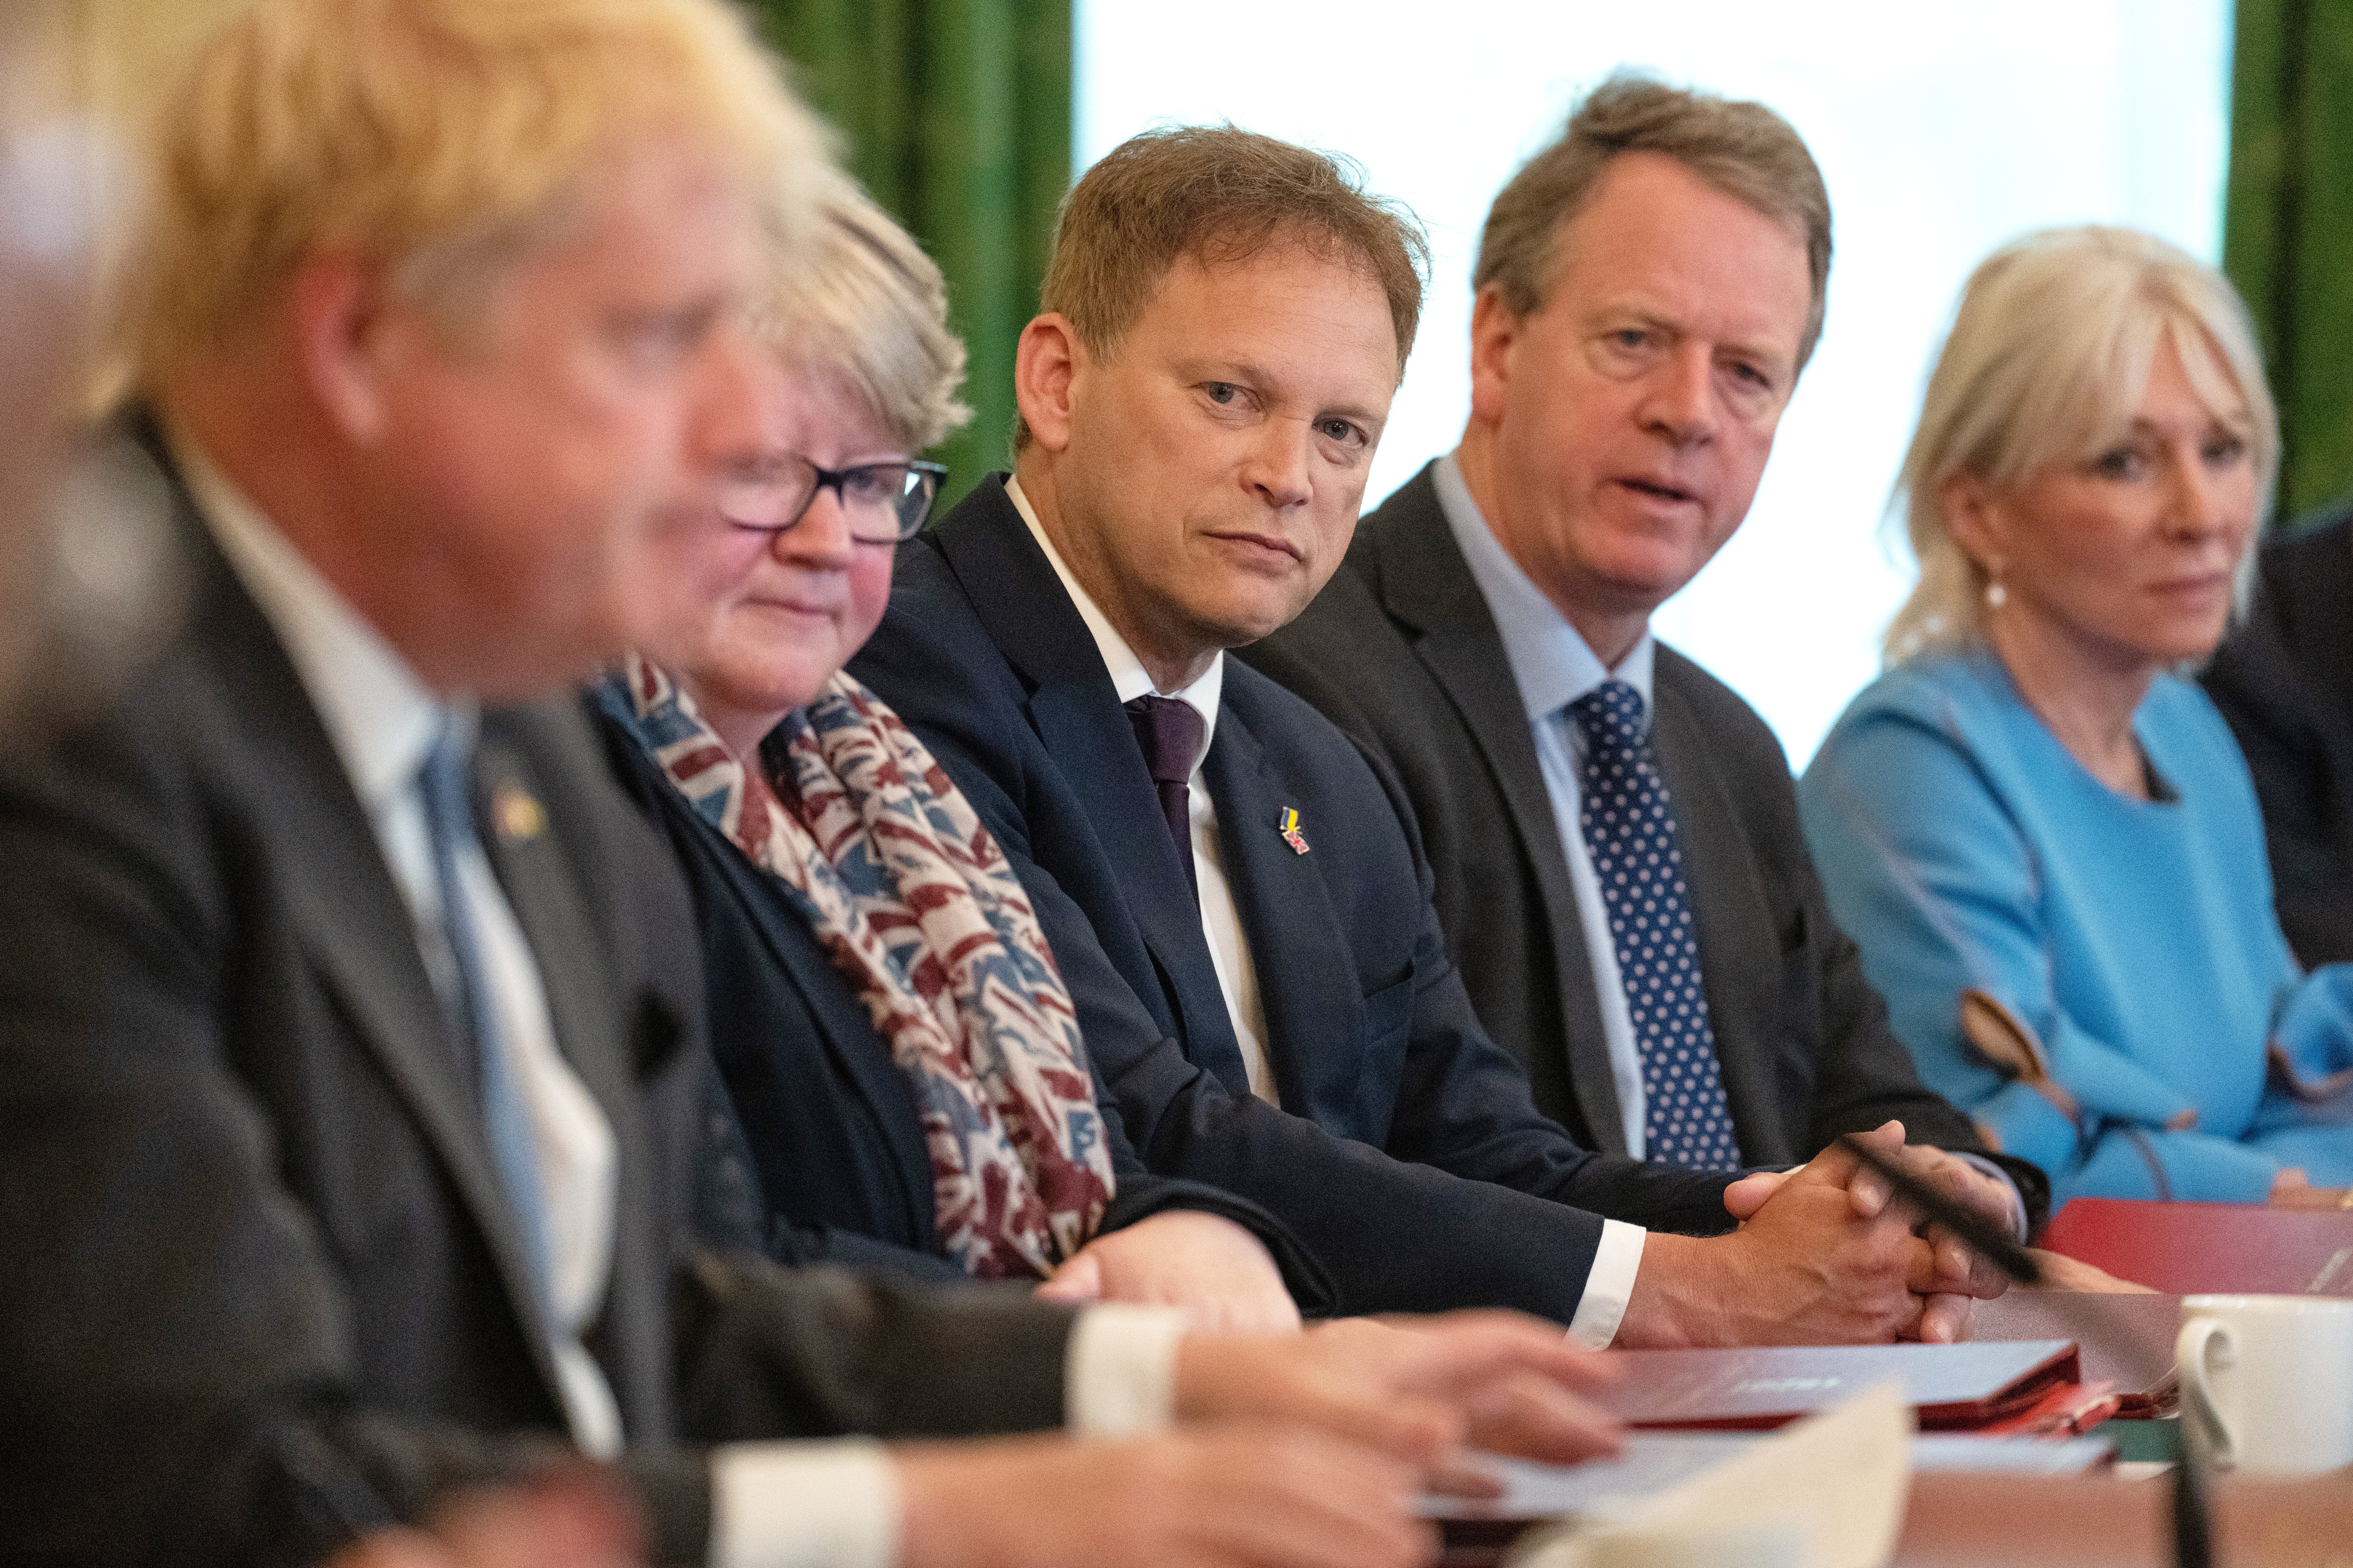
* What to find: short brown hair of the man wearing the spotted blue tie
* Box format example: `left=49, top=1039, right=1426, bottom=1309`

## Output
left=1471, top=73, right=1831, bottom=369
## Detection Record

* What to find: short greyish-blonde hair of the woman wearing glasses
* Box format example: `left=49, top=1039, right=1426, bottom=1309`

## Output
left=751, top=169, right=972, bottom=454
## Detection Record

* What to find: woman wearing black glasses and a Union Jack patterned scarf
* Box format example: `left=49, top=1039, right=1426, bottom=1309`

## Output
left=595, top=183, right=1322, bottom=1328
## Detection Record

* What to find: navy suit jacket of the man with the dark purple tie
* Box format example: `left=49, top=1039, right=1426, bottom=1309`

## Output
left=852, top=477, right=1730, bottom=1321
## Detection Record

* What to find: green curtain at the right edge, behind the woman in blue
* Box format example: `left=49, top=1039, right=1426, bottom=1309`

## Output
left=2224, top=0, right=2353, bottom=527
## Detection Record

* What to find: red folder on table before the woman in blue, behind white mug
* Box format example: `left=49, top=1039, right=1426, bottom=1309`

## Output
left=2040, top=1199, right=2353, bottom=1295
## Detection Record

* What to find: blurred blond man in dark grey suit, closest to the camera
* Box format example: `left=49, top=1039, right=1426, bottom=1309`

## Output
left=0, top=0, right=1619, bottom=1566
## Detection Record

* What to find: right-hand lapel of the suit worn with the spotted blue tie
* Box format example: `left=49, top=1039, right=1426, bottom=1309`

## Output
left=1652, top=677, right=1795, bottom=1161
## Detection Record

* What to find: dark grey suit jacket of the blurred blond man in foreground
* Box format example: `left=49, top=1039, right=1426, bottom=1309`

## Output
left=0, top=430, right=1068, bottom=1563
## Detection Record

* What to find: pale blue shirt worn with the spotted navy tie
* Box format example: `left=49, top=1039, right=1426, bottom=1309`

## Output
left=1430, top=454, right=2026, bottom=1241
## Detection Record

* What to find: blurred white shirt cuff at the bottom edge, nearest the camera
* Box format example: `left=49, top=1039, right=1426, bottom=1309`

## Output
left=711, top=1436, right=899, bottom=1568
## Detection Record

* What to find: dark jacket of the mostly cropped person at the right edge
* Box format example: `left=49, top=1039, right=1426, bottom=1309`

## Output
left=2203, top=512, right=2353, bottom=966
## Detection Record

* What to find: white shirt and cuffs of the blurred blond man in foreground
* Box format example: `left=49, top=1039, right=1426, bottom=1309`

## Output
left=172, top=440, right=1184, bottom=1568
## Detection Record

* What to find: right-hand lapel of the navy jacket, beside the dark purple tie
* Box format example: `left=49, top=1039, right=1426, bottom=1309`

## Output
left=1202, top=710, right=1388, bottom=1131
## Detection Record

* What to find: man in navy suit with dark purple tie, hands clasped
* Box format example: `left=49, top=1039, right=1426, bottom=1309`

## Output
left=852, top=129, right=1998, bottom=1345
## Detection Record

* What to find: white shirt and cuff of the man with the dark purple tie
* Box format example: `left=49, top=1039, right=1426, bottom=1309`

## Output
left=1005, top=480, right=1647, bottom=1349
